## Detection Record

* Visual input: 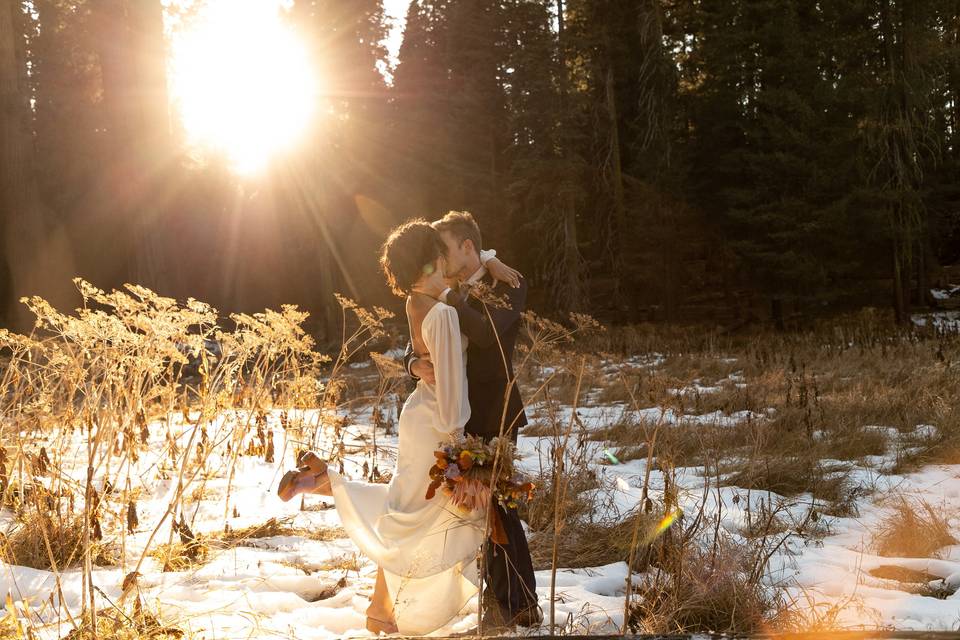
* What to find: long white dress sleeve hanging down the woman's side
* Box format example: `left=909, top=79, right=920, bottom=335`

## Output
left=423, top=303, right=470, bottom=434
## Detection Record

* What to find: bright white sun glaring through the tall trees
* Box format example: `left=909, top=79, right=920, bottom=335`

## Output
left=170, top=0, right=318, bottom=175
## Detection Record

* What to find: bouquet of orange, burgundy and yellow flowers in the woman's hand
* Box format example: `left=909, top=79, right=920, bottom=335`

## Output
left=427, top=435, right=535, bottom=513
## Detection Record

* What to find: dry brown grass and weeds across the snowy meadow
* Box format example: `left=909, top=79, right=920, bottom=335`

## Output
left=0, top=280, right=960, bottom=637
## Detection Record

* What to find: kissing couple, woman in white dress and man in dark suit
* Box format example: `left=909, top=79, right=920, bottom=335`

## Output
left=278, top=211, right=543, bottom=635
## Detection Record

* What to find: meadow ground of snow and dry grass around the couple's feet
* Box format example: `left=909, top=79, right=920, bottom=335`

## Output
left=0, top=292, right=960, bottom=639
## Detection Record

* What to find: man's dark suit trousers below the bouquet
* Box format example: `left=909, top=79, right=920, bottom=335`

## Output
left=484, top=504, right=537, bottom=616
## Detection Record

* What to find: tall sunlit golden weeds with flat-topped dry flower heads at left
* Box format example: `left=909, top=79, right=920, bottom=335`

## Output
left=0, top=278, right=327, bottom=637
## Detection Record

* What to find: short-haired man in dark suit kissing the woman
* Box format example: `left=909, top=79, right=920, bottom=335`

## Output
left=404, top=211, right=543, bottom=633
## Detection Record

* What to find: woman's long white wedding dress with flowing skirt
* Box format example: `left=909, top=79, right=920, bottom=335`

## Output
left=328, top=303, right=487, bottom=635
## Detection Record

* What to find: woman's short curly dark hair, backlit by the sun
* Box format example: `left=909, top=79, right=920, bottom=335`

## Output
left=380, top=218, right=446, bottom=297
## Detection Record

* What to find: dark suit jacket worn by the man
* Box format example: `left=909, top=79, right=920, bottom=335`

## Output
left=404, top=274, right=527, bottom=442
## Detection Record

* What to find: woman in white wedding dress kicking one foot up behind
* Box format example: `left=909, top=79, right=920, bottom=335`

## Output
left=278, top=219, right=487, bottom=635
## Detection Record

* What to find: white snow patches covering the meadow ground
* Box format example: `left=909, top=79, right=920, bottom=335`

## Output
left=0, top=376, right=960, bottom=638
